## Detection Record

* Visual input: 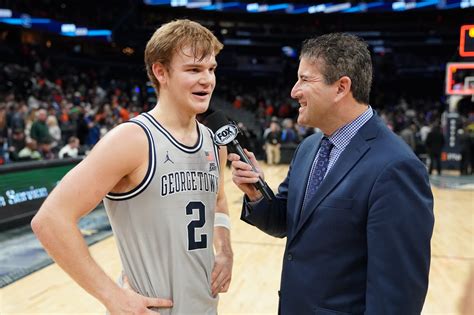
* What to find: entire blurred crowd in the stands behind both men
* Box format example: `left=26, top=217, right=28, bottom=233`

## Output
left=0, top=45, right=474, bottom=174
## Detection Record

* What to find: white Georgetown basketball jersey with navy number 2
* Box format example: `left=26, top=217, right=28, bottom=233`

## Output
left=104, top=113, right=219, bottom=315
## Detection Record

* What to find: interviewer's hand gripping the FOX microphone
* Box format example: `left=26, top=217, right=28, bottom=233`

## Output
left=228, top=149, right=264, bottom=200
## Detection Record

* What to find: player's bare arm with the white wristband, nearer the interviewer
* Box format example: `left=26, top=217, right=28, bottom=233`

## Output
left=211, top=147, right=234, bottom=296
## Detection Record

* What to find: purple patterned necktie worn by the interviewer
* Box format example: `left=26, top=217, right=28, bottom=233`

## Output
left=303, top=137, right=334, bottom=209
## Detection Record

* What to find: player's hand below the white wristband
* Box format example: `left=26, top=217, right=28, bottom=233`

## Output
left=211, top=248, right=234, bottom=297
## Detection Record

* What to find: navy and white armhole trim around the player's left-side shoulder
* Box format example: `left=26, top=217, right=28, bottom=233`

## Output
left=105, top=120, right=156, bottom=201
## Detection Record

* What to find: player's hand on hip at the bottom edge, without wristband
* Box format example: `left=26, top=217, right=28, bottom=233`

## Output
left=108, top=275, right=173, bottom=315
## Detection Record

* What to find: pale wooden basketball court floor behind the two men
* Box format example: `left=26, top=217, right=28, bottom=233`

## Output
left=0, top=165, right=474, bottom=315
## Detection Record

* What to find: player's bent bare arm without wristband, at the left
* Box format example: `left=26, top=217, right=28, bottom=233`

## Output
left=32, top=124, right=172, bottom=314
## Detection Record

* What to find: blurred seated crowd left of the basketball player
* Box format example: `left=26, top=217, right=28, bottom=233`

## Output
left=0, top=45, right=146, bottom=164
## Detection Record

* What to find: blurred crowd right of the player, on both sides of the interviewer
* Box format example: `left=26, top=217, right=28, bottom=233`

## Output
left=224, top=85, right=474, bottom=175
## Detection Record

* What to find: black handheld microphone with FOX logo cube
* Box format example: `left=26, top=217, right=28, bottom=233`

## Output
left=206, top=111, right=275, bottom=201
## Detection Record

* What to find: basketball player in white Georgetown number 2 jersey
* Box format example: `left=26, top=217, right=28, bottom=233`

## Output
left=32, top=20, right=233, bottom=314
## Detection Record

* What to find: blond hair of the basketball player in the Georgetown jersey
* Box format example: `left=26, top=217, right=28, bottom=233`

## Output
left=145, top=19, right=224, bottom=95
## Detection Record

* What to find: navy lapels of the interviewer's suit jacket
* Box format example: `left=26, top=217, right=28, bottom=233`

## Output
left=293, top=113, right=380, bottom=241
